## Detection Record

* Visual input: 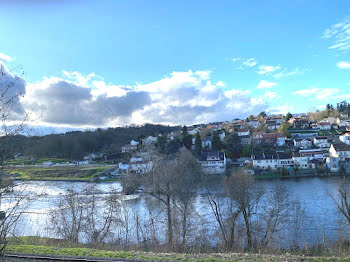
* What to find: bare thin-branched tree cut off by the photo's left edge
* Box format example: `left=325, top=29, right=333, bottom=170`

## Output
left=0, top=62, right=37, bottom=256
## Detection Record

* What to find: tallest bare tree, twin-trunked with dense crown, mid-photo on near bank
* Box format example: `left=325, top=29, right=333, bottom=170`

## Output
left=143, top=148, right=201, bottom=249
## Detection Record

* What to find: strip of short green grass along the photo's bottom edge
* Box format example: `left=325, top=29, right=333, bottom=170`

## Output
left=7, top=244, right=350, bottom=262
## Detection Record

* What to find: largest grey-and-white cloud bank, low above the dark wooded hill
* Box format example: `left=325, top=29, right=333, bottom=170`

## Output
left=17, top=70, right=268, bottom=128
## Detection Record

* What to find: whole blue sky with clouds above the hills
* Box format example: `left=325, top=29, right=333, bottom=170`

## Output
left=0, top=0, right=350, bottom=130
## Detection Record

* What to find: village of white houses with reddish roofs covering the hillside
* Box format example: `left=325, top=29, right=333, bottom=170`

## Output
left=115, top=104, right=350, bottom=176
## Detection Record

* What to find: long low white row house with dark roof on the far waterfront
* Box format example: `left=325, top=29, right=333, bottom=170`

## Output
left=252, top=153, right=293, bottom=169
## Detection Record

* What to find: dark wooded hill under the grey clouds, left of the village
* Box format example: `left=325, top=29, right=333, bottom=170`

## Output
left=7, top=124, right=181, bottom=159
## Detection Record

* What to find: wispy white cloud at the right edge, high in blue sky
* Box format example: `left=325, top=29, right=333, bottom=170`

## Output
left=322, top=17, right=350, bottom=51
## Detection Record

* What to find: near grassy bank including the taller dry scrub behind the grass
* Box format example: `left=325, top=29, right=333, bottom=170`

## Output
left=2, top=236, right=350, bottom=262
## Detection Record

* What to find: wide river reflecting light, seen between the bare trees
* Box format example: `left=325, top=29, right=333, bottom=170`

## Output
left=2, top=176, right=350, bottom=246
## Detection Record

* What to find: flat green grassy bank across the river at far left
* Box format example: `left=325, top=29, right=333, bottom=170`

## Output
left=6, top=165, right=110, bottom=181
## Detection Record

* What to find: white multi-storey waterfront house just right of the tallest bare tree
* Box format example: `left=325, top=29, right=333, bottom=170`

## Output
left=200, top=151, right=226, bottom=175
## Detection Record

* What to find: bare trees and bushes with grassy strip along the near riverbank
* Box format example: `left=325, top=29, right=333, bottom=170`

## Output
left=2, top=148, right=350, bottom=261
